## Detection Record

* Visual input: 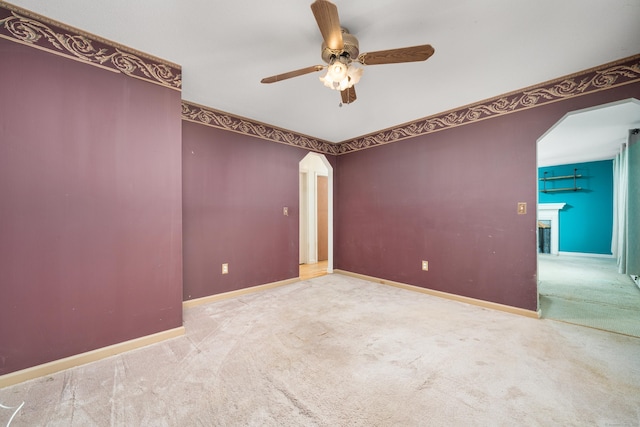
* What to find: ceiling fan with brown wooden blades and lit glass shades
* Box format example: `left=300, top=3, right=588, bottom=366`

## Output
left=261, top=0, right=435, bottom=104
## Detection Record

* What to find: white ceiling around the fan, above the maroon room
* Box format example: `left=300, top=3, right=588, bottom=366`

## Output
left=10, top=0, right=640, bottom=162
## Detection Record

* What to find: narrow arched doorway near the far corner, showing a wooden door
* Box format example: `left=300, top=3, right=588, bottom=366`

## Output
left=299, top=153, right=333, bottom=280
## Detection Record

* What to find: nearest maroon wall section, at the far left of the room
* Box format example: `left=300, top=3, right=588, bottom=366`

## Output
left=0, top=39, right=182, bottom=374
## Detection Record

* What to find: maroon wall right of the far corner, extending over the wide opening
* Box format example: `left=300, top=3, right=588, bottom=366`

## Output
left=335, top=84, right=640, bottom=310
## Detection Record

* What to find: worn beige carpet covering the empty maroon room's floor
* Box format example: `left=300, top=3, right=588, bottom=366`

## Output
left=0, top=274, right=640, bottom=427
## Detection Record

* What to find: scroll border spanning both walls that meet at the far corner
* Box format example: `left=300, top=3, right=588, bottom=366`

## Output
left=182, top=55, right=640, bottom=156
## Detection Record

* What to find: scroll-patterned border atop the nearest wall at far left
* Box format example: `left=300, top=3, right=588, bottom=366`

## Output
left=0, top=2, right=182, bottom=90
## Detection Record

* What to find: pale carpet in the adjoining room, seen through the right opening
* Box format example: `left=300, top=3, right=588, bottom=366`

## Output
left=538, top=255, right=640, bottom=337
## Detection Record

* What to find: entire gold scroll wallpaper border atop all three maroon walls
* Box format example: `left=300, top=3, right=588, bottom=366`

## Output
left=0, top=2, right=640, bottom=155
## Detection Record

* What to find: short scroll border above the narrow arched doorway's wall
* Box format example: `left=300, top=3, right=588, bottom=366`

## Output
left=182, top=101, right=340, bottom=155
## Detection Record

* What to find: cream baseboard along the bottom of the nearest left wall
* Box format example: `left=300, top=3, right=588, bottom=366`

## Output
left=0, top=326, right=185, bottom=388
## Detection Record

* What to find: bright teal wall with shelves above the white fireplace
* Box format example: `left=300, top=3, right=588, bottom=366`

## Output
left=538, top=160, right=613, bottom=255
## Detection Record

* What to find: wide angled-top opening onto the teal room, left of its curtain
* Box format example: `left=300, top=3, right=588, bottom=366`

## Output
left=537, top=99, right=640, bottom=337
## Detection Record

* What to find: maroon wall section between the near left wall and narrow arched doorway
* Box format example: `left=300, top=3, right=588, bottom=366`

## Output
left=182, top=121, right=335, bottom=300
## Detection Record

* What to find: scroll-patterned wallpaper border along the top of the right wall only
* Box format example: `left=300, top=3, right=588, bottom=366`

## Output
left=339, top=55, right=640, bottom=154
